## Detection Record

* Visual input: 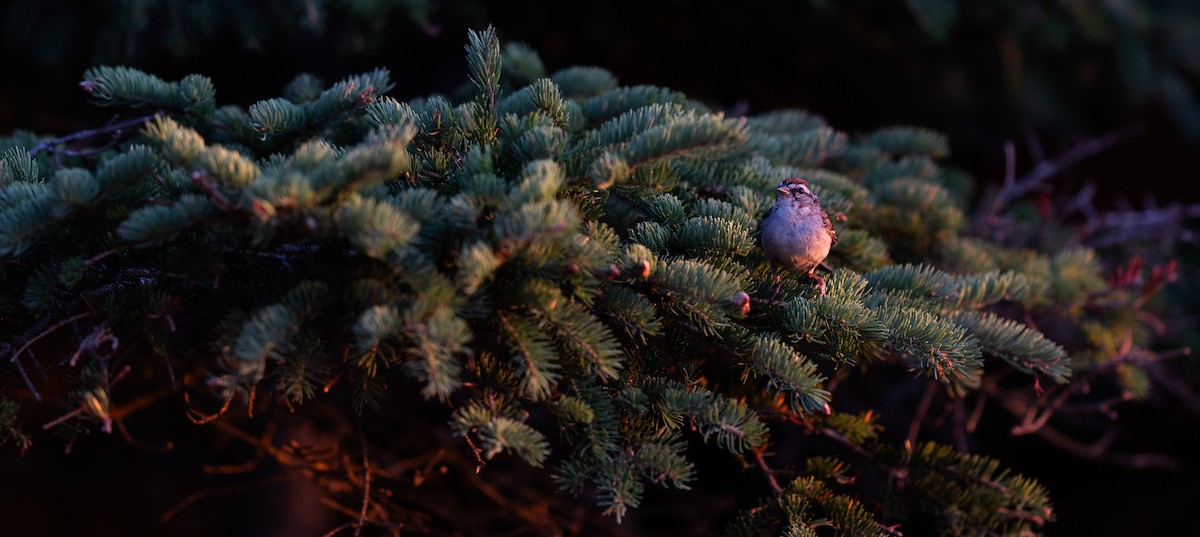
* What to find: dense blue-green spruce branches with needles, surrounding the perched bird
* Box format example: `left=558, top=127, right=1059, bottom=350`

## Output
left=0, top=24, right=1180, bottom=535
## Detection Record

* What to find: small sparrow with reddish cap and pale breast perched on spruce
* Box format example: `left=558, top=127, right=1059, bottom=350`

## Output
left=758, top=177, right=838, bottom=296
